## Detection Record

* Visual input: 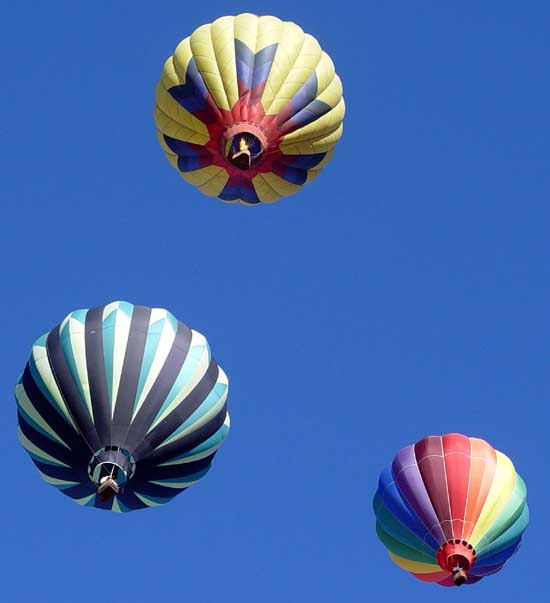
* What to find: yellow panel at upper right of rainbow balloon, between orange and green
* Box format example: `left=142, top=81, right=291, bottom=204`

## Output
left=470, top=450, right=517, bottom=548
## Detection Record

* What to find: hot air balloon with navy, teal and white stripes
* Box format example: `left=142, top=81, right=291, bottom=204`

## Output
left=15, top=301, right=229, bottom=512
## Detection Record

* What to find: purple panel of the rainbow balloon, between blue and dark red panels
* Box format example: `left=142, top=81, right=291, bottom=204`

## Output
left=392, top=446, right=446, bottom=544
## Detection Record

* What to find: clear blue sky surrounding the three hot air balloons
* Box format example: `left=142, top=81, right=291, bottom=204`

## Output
left=0, top=0, right=550, bottom=603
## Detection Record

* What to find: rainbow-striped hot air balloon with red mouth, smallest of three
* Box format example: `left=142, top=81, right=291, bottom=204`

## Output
left=374, top=433, right=529, bottom=586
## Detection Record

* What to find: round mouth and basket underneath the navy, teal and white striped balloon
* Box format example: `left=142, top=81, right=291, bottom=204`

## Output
left=88, top=446, right=136, bottom=501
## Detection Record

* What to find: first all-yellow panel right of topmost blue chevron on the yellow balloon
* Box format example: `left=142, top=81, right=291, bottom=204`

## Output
left=262, top=22, right=305, bottom=113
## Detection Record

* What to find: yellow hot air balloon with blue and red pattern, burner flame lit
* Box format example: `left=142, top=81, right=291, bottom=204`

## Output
left=154, top=14, right=345, bottom=205
